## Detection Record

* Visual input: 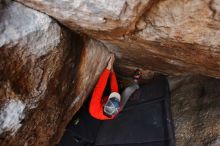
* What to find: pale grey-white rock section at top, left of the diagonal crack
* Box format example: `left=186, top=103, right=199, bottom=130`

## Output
left=15, top=0, right=153, bottom=35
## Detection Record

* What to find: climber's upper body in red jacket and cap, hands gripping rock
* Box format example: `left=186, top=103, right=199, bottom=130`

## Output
left=89, top=55, right=121, bottom=120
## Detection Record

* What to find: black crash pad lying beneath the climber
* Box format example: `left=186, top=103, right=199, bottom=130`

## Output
left=60, top=77, right=175, bottom=146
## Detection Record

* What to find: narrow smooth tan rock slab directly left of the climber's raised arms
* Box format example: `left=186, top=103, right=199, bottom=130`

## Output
left=51, top=40, right=109, bottom=143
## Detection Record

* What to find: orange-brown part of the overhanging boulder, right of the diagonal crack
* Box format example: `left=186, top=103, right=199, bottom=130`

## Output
left=100, top=0, right=220, bottom=77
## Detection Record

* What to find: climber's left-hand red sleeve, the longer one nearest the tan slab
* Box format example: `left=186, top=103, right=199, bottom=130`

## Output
left=89, top=69, right=110, bottom=119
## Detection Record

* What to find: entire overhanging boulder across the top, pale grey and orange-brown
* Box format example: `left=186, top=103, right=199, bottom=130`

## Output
left=17, top=0, right=220, bottom=77
